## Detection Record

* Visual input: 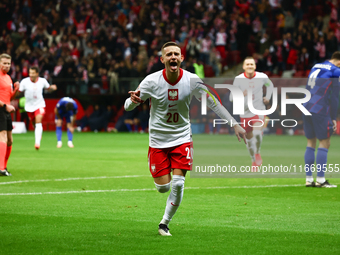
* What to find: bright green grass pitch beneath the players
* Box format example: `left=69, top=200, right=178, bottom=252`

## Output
left=0, top=132, right=340, bottom=254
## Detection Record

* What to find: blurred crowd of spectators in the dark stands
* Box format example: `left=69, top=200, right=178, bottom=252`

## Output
left=0, top=0, right=340, bottom=96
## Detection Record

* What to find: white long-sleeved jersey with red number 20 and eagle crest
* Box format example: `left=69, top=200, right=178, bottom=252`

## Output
left=124, top=69, right=236, bottom=148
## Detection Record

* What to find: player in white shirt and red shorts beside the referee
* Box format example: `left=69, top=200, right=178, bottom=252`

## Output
left=19, top=66, right=57, bottom=150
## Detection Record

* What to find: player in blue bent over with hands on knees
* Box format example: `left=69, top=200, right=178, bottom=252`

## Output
left=54, top=97, right=78, bottom=148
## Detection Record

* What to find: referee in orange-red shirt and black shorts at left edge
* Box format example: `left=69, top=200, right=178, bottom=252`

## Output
left=0, top=54, right=19, bottom=176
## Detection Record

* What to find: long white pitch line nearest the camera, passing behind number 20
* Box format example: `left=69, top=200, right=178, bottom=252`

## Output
left=0, top=184, right=304, bottom=196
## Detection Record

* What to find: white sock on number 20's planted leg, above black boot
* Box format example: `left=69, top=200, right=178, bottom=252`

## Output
left=160, top=175, right=185, bottom=225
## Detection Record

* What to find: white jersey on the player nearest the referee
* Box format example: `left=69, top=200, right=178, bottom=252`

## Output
left=19, top=77, right=50, bottom=112
